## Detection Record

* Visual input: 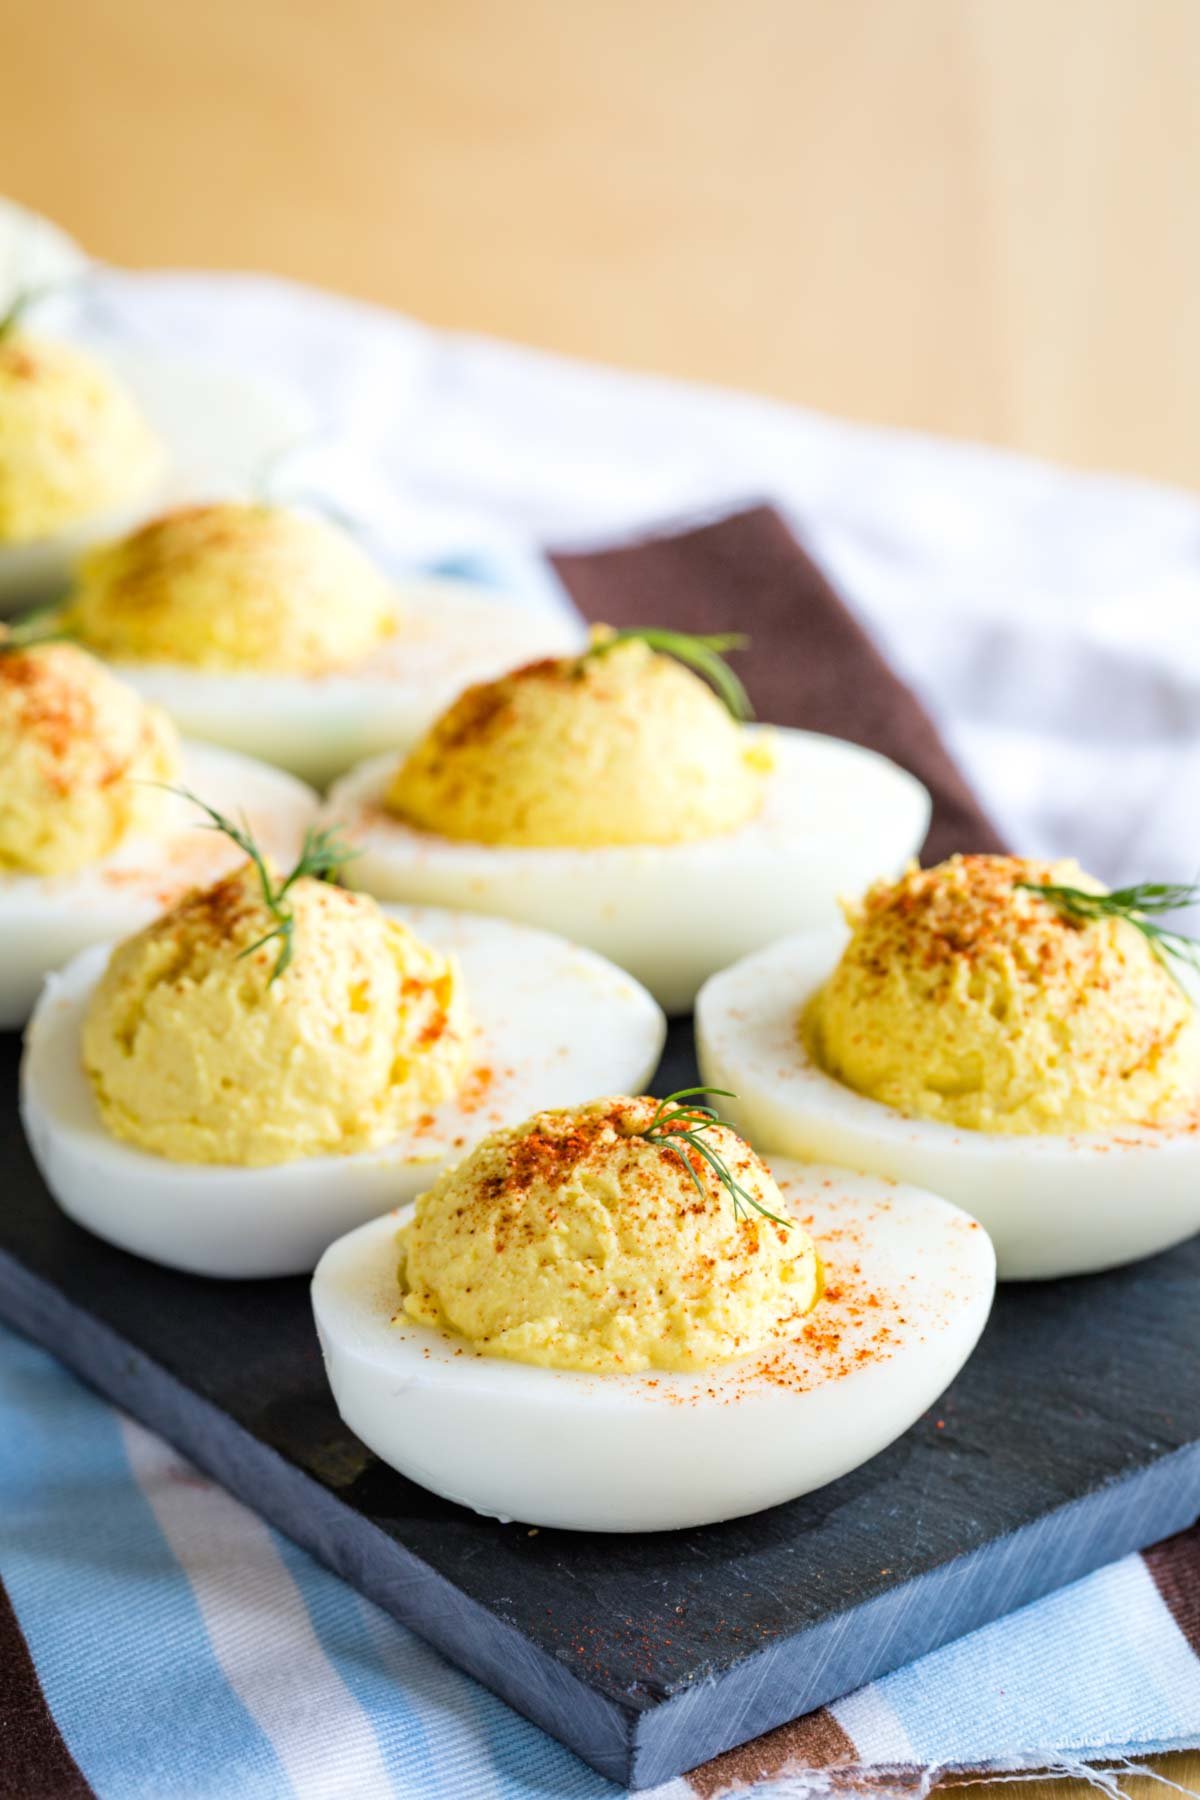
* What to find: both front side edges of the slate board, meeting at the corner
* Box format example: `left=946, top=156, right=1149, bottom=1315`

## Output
left=9, top=1251, right=1200, bottom=1787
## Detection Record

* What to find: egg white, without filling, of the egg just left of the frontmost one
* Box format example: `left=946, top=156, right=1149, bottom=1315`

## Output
left=22, top=907, right=666, bottom=1276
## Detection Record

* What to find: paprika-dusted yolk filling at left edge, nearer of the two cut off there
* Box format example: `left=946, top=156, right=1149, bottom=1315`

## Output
left=0, top=644, right=180, bottom=875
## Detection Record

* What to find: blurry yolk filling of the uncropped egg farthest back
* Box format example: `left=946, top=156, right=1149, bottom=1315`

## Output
left=68, top=500, right=396, bottom=675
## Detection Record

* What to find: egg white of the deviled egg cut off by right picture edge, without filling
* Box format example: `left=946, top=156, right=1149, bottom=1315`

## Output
left=696, top=932, right=1200, bottom=1282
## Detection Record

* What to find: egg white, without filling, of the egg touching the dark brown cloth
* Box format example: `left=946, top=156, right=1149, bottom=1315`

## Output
left=324, top=725, right=930, bottom=1013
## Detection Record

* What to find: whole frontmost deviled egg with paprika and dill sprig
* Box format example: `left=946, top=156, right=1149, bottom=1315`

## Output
left=313, top=1094, right=995, bottom=1532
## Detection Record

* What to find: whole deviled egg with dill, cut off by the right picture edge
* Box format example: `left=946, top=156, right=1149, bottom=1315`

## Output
left=696, top=857, right=1200, bottom=1278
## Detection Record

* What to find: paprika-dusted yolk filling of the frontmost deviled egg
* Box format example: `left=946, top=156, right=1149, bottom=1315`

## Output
left=403, top=1100, right=820, bottom=1373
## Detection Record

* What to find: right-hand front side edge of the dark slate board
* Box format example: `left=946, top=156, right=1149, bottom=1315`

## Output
left=631, top=1444, right=1200, bottom=1787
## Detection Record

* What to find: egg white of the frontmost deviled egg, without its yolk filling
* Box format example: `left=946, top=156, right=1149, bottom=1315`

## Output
left=313, top=1163, right=995, bottom=1532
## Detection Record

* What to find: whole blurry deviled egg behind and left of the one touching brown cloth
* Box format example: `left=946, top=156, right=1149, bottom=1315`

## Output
left=61, top=500, right=583, bottom=785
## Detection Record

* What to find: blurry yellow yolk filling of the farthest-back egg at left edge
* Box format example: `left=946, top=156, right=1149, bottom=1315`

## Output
left=0, top=331, right=164, bottom=544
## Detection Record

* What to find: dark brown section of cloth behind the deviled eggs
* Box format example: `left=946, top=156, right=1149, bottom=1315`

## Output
left=551, top=506, right=1006, bottom=862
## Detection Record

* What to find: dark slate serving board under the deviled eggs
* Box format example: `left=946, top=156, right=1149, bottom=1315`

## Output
left=0, top=1024, right=1200, bottom=1787
